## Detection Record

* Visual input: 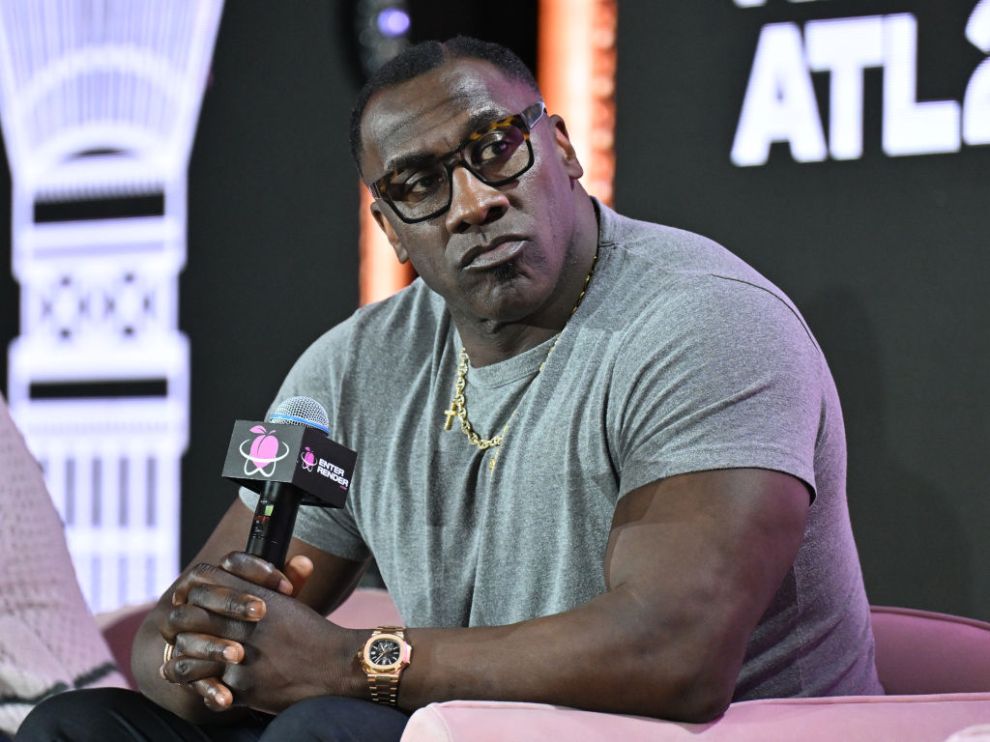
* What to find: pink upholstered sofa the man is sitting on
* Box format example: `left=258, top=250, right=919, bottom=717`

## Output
left=102, top=590, right=990, bottom=742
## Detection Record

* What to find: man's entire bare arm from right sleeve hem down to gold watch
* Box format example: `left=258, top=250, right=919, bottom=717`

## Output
left=390, top=469, right=809, bottom=721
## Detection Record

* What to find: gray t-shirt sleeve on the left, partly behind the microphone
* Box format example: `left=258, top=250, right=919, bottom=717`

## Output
left=240, top=320, right=370, bottom=561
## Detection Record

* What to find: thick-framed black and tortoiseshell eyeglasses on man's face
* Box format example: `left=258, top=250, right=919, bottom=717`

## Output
left=371, top=101, right=547, bottom=224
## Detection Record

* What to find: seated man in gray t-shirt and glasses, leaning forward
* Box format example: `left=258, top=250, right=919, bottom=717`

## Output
left=17, top=39, right=881, bottom=739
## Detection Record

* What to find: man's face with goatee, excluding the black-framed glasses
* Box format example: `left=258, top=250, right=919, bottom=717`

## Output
left=361, top=59, right=582, bottom=323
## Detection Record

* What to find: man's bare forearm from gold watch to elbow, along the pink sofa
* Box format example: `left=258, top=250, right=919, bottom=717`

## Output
left=399, top=589, right=742, bottom=721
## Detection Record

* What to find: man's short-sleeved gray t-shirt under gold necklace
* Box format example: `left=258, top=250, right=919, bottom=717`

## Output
left=242, top=204, right=882, bottom=700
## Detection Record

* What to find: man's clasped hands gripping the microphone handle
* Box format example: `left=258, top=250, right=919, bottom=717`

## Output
left=162, top=552, right=357, bottom=712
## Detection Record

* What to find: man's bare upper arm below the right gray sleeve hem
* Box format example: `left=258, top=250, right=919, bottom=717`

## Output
left=605, top=469, right=810, bottom=679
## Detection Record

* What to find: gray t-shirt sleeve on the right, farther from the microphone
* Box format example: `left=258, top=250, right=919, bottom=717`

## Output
left=612, top=276, right=825, bottom=497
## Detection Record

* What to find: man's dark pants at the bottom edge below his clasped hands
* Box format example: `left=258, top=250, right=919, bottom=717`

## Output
left=14, top=688, right=408, bottom=742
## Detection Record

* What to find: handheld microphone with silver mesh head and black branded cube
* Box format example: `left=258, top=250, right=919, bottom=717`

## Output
left=223, top=397, right=357, bottom=569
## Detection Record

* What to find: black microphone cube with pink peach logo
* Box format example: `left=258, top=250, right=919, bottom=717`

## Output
left=223, top=420, right=357, bottom=508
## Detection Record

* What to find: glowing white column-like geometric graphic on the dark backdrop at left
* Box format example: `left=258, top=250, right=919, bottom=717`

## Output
left=0, top=0, right=222, bottom=611
